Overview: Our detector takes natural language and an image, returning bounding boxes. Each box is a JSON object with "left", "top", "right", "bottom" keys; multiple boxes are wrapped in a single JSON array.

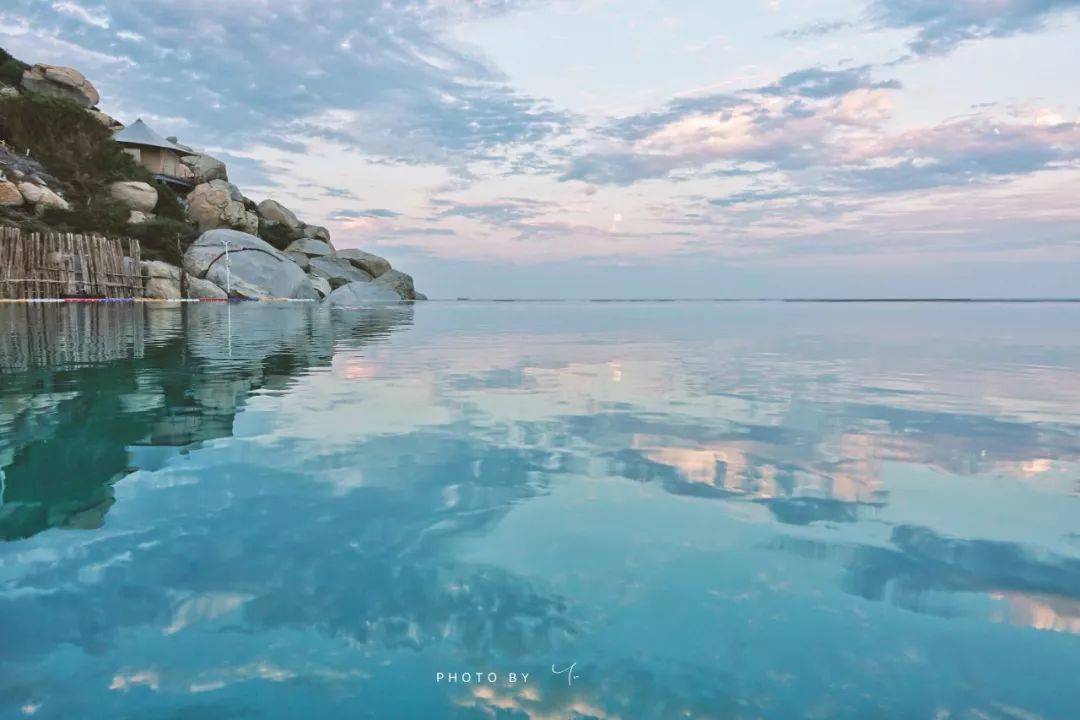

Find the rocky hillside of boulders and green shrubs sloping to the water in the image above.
[{"left": 0, "top": 51, "right": 427, "bottom": 307}]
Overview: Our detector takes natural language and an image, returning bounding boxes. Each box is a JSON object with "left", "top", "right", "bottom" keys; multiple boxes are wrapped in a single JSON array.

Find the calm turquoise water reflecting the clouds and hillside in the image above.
[{"left": 0, "top": 302, "right": 1080, "bottom": 720}]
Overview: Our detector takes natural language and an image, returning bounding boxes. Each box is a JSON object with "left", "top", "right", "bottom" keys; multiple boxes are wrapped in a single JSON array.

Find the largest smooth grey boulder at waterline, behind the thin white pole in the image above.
[{"left": 184, "top": 230, "right": 319, "bottom": 300}]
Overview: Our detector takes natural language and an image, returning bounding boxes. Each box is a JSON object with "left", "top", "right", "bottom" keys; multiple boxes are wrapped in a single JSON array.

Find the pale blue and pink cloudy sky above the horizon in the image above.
[{"left": 0, "top": 0, "right": 1080, "bottom": 298}]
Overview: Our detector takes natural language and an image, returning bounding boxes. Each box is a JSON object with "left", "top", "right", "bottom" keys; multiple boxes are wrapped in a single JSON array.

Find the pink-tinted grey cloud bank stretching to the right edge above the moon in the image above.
[{"left": 559, "top": 49, "right": 1080, "bottom": 207}]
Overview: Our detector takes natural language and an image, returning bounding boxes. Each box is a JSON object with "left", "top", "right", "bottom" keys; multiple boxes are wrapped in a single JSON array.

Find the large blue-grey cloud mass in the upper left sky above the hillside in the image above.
[{"left": 2, "top": 0, "right": 569, "bottom": 163}]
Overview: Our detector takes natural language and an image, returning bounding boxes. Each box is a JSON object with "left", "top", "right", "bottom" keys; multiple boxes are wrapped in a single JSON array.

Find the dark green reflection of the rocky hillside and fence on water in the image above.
[{"left": 0, "top": 304, "right": 413, "bottom": 540}]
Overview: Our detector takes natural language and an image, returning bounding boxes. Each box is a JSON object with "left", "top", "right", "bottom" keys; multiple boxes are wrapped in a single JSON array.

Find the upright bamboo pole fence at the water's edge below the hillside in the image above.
[{"left": 0, "top": 228, "right": 143, "bottom": 299}]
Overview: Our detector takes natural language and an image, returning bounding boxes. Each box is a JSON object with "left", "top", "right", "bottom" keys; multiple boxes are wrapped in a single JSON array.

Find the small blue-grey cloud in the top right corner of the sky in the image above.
[{"left": 868, "top": 0, "right": 1080, "bottom": 55}]
